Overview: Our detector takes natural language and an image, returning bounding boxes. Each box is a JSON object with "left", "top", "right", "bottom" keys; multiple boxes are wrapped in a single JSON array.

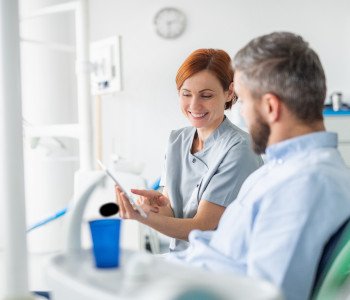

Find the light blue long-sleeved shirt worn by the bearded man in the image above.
[{"left": 170, "top": 132, "right": 350, "bottom": 300}]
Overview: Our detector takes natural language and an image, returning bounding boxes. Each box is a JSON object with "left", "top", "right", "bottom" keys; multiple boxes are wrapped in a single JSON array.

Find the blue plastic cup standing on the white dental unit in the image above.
[{"left": 89, "top": 219, "right": 121, "bottom": 268}]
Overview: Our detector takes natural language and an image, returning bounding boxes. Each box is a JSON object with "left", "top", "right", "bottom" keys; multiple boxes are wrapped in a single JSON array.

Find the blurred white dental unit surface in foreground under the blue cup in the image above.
[{"left": 47, "top": 250, "right": 283, "bottom": 300}]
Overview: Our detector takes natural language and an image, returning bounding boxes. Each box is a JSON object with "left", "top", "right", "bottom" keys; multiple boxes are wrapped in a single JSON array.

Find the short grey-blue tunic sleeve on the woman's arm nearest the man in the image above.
[{"left": 200, "top": 143, "right": 262, "bottom": 207}]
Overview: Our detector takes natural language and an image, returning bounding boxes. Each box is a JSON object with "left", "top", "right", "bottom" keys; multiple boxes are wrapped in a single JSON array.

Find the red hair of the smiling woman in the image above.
[{"left": 175, "top": 49, "right": 235, "bottom": 109}]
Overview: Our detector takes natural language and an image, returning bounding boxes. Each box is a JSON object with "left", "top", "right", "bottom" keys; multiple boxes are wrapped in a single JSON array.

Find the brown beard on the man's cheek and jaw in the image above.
[{"left": 250, "top": 112, "right": 271, "bottom": 154}]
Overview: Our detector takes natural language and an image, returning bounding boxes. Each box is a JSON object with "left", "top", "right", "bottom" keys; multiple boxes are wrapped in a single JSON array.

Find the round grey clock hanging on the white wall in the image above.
[{"left": 154, "top": 7, "right": 186, "bottom": 39}]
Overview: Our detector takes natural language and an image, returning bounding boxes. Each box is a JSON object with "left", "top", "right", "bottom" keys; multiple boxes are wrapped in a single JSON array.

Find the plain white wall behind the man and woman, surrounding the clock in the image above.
[{"left": 90, "top": 0, "right": 350, "bottom": 180}]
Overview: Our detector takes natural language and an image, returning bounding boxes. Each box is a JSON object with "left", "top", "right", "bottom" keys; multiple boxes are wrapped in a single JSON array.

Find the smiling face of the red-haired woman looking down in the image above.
[{"left": 179, "top": 70, "right": 233, "bottom": 132}]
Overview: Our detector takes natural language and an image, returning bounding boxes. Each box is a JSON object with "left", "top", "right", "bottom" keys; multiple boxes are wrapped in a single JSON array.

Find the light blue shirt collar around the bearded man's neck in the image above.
[{"left": 266, "top": 131, "right": 338, "bottom": 161}]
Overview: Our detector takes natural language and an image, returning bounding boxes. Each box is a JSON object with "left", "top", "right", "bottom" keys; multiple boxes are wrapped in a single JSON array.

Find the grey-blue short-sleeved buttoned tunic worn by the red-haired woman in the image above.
[{"left": 160, "top": 117, "right": 263, "bottom": 251}]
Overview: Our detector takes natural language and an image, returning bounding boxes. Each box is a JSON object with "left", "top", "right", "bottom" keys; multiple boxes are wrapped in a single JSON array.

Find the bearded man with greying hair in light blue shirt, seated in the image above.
[{"left": 167, "top": 32, "right": 350, "bottom": 300}]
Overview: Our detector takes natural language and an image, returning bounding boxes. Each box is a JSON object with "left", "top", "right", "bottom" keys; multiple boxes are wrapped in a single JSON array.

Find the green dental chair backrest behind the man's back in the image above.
[{"left": 310, "top": 218, "right": 350, "bottom": 300}]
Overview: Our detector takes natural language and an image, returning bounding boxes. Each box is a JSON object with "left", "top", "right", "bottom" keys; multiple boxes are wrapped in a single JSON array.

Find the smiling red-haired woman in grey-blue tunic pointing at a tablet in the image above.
[{"left": 116, "top": 49, "right": 262, "bottom": 251}]
